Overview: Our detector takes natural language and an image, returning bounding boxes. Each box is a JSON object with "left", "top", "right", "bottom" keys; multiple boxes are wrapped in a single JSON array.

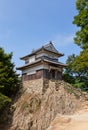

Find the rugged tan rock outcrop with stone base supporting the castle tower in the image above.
[{"left": 9, "top": 79, "right": 86, "bottom": 130}]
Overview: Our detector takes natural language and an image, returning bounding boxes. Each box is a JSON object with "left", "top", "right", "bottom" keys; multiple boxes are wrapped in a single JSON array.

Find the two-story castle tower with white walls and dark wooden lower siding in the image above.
[{"left": 17, "top": 42, "right": 66, "bottom": 94}]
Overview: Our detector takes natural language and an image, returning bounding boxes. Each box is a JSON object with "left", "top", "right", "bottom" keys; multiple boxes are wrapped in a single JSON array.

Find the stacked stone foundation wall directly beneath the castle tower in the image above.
[{"left": 23, "top": 78, "right": 55, "bottom": 94}]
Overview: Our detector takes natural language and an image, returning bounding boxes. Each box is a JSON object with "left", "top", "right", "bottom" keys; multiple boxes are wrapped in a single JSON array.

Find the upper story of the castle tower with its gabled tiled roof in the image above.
[{"left": 20, "top": 42, "right": 64, "bottom": 65}]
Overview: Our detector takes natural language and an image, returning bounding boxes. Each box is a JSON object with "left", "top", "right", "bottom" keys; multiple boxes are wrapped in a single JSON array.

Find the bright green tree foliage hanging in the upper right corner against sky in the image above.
[{"left": 73, "top": 0, "right": 88, "bottom": 49}]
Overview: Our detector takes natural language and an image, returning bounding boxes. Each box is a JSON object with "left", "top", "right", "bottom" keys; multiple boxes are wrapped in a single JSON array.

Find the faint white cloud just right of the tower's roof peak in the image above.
[{"left": 53, "top": 34, "right": 74, "bottom": 47}]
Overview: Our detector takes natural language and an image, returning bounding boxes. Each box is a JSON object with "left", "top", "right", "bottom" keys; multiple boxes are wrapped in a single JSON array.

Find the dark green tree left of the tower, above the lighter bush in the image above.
[{"left": 0, "top": 48, "right": 18, "bottom": 97}]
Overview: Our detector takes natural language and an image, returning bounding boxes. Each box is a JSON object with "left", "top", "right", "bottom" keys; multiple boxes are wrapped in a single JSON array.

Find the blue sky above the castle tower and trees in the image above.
[{"left": 0, "top": 0, "right": 80, "bottom": 72}]
